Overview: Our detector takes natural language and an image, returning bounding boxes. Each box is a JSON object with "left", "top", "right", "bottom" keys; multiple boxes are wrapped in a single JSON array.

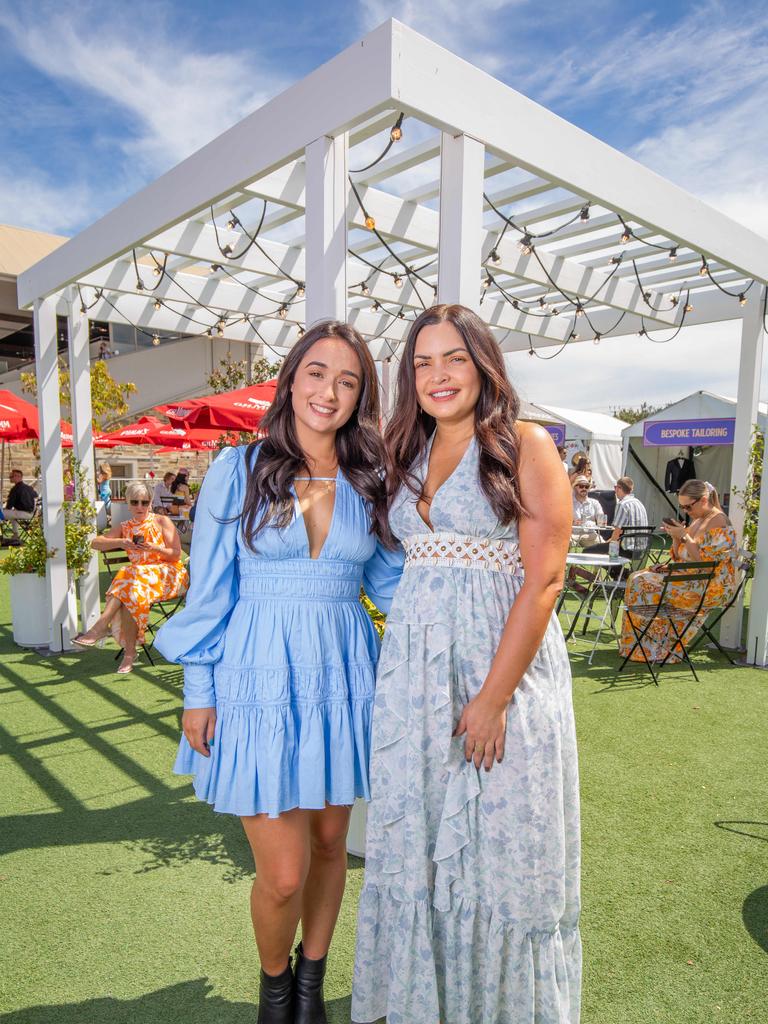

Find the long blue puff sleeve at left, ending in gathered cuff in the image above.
[{"left": 156, "top": 447, "right": 245, "bottom": 709}]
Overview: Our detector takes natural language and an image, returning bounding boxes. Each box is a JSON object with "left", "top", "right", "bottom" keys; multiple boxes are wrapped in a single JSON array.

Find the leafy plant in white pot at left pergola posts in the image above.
[{"left": 0, "top": 459, "right": 96, "bottom": 647}]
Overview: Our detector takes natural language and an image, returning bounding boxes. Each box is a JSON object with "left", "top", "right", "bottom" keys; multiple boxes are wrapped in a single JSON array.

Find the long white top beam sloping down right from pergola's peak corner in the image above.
[{"left": 392, "top": 23, "right": 768, "bottom": 282}]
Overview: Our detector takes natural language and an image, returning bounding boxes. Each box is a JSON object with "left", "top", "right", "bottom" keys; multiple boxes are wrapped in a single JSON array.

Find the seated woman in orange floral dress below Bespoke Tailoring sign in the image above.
[{"left": 618, "top": 480, "right": 738, "bottom": 663}]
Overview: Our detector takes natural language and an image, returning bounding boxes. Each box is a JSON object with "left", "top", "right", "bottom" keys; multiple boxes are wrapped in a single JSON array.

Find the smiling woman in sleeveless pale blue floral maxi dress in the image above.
[{"left": 352, "top": 306, "right": 581, "bottom": 1024}]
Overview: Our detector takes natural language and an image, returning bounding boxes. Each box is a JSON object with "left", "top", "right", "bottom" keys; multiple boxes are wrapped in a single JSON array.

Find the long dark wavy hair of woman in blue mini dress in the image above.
[{"left": 242, "top": 321, "right": 392, "bottom": 550}]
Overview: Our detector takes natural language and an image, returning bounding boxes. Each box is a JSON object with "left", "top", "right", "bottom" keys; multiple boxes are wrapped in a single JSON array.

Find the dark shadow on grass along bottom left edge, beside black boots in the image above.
[{"left": 0, "top": 978, "right": 351, "bottom": 1024}]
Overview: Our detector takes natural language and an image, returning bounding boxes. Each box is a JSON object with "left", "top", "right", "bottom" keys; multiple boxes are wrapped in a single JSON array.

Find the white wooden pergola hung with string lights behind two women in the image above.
[{"left": 18, "top": 20, "right": 768, "bottom": 665}]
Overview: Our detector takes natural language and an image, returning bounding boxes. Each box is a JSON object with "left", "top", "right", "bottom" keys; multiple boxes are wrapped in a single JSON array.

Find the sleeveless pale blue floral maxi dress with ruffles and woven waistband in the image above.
[{"left": 352, "top": 441, "right": 582, "bottom": 1024}]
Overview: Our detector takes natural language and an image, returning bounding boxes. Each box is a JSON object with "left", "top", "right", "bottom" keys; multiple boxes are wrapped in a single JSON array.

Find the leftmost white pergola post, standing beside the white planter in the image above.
[{"left": 34, "top": 297, "right": 72, "bottom": 651}]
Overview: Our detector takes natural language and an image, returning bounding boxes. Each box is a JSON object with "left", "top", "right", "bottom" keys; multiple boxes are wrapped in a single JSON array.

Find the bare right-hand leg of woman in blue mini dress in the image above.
[{"left": 301, "top": 807, "right": 352, "bottom": 959}]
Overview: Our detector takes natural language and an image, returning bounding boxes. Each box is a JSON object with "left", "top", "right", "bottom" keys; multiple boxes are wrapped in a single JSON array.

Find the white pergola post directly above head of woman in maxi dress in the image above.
[{"left": 437, "top": 132, "right": 485, "bottom": 311}]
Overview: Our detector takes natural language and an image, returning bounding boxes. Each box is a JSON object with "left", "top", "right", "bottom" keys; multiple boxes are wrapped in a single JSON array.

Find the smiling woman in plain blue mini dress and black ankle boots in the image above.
[{"left": 158, "top": 322, "right": 402, "bottom": 1024}]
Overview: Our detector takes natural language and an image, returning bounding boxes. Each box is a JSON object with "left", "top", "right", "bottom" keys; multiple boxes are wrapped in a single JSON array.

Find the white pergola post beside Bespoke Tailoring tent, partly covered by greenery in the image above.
[{"left": 720, "top": 288, "right": 763, "bottom": 649}]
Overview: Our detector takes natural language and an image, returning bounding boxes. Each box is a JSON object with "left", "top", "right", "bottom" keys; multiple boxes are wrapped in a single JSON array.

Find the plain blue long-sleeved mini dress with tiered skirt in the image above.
[{"left": 156, "top": 446, "right": 403, "bottom": 817}]
